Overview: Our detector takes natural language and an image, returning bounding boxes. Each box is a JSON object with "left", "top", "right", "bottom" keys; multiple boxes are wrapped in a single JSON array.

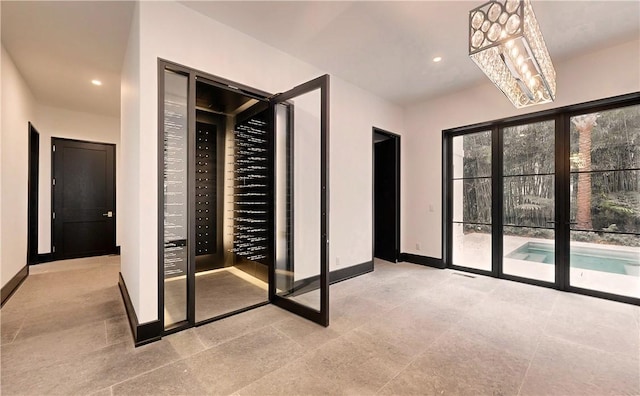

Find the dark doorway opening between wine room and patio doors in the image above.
[{"left": 373, "top": 128, "right": 400, "bottom": 263}]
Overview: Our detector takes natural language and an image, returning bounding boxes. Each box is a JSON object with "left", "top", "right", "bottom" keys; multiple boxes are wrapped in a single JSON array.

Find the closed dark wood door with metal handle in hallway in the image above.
[{"left": 52, "top": 138, "right": 116, "bottom": 259}]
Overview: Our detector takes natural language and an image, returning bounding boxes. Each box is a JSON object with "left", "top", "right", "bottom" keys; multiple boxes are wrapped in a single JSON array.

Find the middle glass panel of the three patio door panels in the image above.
[{"left": 502, "top": 120, "right": 556, "bottom": 282}]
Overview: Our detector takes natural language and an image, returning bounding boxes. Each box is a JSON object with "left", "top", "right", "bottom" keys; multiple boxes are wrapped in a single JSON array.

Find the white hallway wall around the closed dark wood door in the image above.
[{"left": 34, "top": 105, "right": 122, "bottom": 253}]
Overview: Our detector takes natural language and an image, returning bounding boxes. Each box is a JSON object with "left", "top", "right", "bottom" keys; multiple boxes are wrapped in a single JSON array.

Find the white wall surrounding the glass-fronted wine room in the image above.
[{"left": 122, "top": 2, "right": 403, "bottom": 322}]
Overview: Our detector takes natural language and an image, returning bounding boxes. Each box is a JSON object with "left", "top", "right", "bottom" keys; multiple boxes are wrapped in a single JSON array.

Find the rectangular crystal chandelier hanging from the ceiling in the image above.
[{"left": 469, "top": 0, "right": 556, "bottom": 108}]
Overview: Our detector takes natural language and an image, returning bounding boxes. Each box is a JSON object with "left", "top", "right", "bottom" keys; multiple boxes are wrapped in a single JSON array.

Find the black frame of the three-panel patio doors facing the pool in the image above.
[{"left": 442, "top": 92, "right": 640, "bottom": 305}]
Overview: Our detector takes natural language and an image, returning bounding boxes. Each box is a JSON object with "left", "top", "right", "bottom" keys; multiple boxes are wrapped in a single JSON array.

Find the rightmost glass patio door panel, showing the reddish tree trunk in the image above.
[{"left": 569, "top": 105, "right": 640, "bottom": 298}]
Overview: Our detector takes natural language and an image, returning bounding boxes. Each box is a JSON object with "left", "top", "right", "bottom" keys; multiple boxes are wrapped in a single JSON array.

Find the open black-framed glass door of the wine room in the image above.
[{"left": 269, "top": 75, "right": 329, "bottom": 326}]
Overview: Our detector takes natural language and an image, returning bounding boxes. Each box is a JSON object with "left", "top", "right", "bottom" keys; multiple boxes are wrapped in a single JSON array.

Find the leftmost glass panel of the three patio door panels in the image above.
[{"left": 451, "top": 131, "right": 492, "bottom": 271}]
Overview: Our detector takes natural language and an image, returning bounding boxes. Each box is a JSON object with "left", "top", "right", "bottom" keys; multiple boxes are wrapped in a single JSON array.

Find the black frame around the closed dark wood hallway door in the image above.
[{"left": 47, "top": 136, "right": 118, "bottom": 261}]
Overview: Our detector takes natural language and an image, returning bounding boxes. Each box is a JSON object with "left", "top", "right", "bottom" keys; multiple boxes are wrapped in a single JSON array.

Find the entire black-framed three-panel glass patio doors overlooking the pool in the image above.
[{"left": 443, "top": 93, "right": 640, "bottom": 304}]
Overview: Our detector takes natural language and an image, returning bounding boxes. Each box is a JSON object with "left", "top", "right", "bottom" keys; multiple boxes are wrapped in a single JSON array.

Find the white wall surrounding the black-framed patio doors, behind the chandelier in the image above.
[{"left": 402, "top": 39, "right": 640, "bottom": 258}]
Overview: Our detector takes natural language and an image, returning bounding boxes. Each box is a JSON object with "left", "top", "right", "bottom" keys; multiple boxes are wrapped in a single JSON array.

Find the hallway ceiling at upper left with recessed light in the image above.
[{"left": 0, "top": 0, "right": 134, "bottom": 117}]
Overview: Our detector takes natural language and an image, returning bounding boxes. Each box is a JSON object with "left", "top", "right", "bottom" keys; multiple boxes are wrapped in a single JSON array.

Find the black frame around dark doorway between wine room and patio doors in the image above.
[{"left": 371, "top": 127, "right": 401, "bottom": 262}]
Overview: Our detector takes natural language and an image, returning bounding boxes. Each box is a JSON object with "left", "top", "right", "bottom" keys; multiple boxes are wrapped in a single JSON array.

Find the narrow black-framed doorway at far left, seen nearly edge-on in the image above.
[{"left": 27, "top": 122, "right": 40, "bottom": 265}]
